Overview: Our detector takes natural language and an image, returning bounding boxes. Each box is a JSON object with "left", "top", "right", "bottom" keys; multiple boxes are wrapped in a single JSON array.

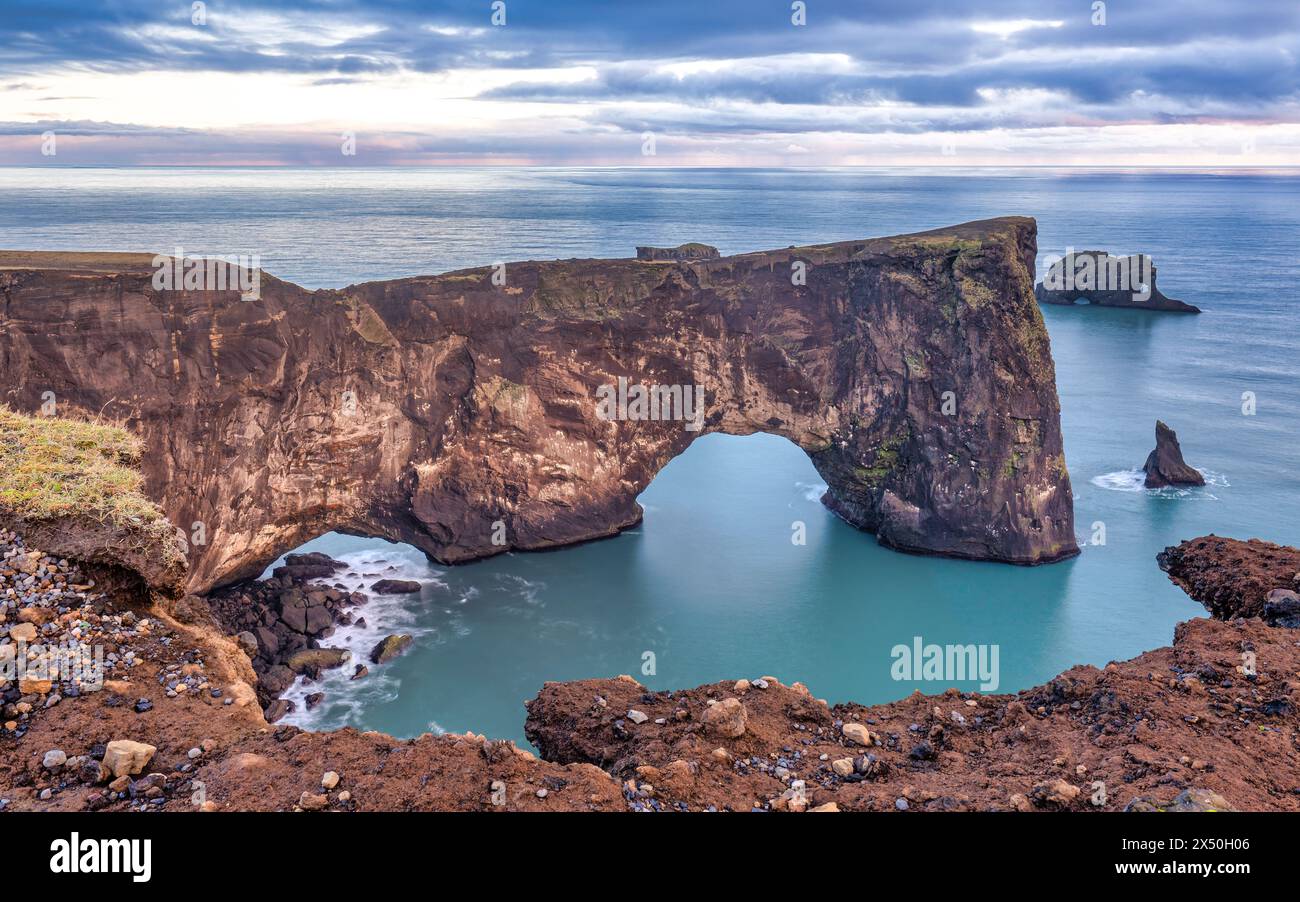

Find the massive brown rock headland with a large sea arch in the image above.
[{"left": 0, "top": 217, "right": 1078, "bottom": 591}]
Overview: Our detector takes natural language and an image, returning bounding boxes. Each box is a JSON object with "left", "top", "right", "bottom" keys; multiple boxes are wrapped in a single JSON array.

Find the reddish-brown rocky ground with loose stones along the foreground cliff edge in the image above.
[{"left": 0, "top": 534, "right": 1300, "bottom": 812}]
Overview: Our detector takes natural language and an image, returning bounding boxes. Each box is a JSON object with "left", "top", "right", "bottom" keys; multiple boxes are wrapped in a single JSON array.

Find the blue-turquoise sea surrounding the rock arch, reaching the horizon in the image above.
[{"left": 0, "top": 169, "right": 1300, "bottom": 740}]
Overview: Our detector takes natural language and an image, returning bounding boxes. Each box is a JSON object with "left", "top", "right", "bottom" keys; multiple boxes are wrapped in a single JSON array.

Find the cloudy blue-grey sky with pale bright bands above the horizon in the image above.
[{"left": 0, "top": 0, "right": 1300, "bottom": 166}]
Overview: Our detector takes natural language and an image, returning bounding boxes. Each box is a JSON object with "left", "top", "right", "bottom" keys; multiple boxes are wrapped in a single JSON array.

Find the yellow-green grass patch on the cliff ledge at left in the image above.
[{"left": 0, "top": 406, "right": 173, "bottom": 534}]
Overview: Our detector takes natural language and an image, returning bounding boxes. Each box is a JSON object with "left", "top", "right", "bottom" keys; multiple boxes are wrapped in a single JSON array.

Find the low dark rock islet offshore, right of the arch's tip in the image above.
[{"left": 1034, "top": 251, "right": 1201, "bottom": 313}]
